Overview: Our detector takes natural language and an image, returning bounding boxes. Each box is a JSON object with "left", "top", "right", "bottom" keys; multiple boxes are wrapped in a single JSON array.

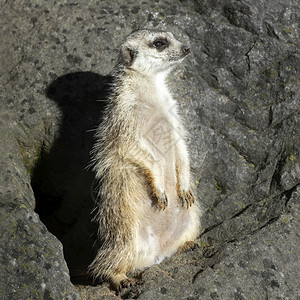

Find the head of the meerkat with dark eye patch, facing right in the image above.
[{"left": 121, "top": 30, "right": 190, "bottom": 74}]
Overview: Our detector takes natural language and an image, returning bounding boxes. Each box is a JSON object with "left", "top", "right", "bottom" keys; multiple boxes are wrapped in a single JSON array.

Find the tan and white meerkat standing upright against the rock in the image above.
[{"left": 89, "top": 30, "right": 200, "bottom": 290}]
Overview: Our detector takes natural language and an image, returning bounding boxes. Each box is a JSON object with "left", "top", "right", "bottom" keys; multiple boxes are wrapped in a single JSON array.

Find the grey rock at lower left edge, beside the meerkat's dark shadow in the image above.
[{"left": 0, "top": 123, "right": 78, "bottom": 299}]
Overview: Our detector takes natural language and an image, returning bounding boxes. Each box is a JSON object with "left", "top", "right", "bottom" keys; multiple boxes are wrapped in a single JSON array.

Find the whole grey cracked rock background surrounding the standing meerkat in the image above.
[{"left": 0, "top": 0, "right": 300, "bottom": 300}]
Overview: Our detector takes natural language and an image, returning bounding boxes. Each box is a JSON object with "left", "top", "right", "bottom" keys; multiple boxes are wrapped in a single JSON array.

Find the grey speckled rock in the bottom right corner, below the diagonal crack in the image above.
[{"left": 193, "top": 187, "right": 300, "bottom": 299}]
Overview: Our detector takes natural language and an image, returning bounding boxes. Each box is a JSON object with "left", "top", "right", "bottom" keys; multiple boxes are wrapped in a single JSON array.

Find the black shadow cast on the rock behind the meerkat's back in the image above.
[{"left": 31, "top": 72, "right": 112, "bottom": 282}]
